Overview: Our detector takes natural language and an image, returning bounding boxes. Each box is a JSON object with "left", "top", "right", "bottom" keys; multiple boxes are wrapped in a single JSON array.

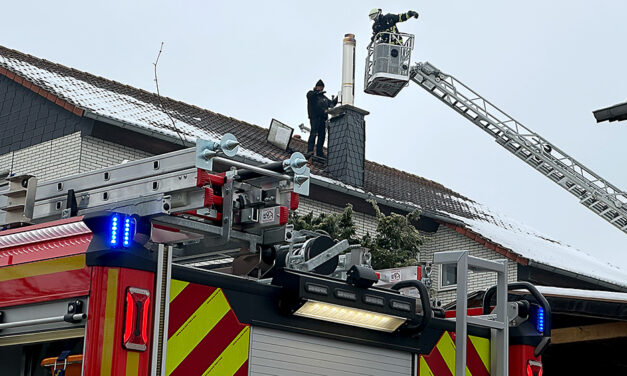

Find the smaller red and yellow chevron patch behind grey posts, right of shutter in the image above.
[{"left": 419, "top": 332, "right": 490, "bottom": 376}]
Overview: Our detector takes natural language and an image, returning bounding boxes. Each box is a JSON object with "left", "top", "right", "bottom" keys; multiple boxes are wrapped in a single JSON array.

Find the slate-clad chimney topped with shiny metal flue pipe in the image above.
[{"left": 325, "top": 34, "right": 369, "bottom": 187}]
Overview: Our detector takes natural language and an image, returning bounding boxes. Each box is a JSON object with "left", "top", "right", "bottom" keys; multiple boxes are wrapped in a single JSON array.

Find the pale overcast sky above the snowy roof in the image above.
[{"left": 0, "top": 0, "right": 627, "bottom": 269}]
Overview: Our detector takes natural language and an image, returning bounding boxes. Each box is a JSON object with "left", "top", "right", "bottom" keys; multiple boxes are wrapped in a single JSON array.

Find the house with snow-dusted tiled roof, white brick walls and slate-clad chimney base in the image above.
[{"left": 0, "top": 47, "right": 627, "bottom": 303}]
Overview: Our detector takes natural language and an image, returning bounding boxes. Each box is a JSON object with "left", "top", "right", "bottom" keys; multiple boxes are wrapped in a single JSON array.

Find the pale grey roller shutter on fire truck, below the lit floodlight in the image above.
[{"left": 249, "top": 326, "right": 412, "bottom": 376}]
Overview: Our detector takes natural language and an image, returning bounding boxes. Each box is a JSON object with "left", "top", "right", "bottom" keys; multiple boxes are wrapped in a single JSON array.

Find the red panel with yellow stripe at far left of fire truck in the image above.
[{"left": 0, "top": 254, "right": 91, "bottom": 307}]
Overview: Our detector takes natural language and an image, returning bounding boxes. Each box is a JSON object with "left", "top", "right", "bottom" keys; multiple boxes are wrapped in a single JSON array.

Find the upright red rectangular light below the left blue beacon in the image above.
[{"left": 122, "top": 287, "right": 150, "bottom": 351}]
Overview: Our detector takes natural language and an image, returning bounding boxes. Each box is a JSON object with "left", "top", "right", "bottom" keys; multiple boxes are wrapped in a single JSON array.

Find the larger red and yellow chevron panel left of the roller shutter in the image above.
[{"left": 166, "top": 280, "right": 250, "bottom": 376}]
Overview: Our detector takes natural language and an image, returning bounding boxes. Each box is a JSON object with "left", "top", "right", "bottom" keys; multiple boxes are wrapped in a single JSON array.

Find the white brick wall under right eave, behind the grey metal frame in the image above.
[{"left": 420, "top": 226, "right": 518, "bottom": 304}]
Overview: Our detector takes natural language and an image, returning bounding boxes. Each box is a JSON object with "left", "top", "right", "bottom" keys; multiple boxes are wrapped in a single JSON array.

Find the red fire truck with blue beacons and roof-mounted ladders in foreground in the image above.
[{"left": 0, "top": 135, "right": 550, "bottom": 376}]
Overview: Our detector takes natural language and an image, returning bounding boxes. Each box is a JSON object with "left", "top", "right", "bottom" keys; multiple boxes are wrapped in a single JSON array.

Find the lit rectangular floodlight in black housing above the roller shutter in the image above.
[{"left": 272, "top": 269, "right": 420, "bottom": 333}]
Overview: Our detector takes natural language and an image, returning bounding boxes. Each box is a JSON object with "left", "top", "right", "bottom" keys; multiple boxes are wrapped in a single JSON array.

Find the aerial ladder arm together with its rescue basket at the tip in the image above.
[{"left": 364, "top": 33, "right": 627, "bottom": 234}]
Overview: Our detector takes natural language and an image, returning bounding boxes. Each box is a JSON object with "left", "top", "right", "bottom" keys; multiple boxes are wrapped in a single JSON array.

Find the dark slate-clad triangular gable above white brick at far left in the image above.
[{"left": 0, "top": 76, "right": 93, "bottom": 155}]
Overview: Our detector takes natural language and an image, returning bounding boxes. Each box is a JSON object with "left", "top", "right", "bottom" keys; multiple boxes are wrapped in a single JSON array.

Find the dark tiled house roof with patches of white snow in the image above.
[{"left": 0, "top": 46, "right": 627, "bottom": 290}]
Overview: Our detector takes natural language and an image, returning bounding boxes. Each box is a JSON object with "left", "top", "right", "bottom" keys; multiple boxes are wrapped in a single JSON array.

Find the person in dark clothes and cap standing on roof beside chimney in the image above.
[{"left": 307, "top": 80, "right": 337, "bottom": 158}]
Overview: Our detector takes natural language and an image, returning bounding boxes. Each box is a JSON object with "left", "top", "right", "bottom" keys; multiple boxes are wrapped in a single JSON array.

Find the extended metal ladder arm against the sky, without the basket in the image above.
[{"left": 411, "top": 62, "right": 627, "bottom": 234}]
